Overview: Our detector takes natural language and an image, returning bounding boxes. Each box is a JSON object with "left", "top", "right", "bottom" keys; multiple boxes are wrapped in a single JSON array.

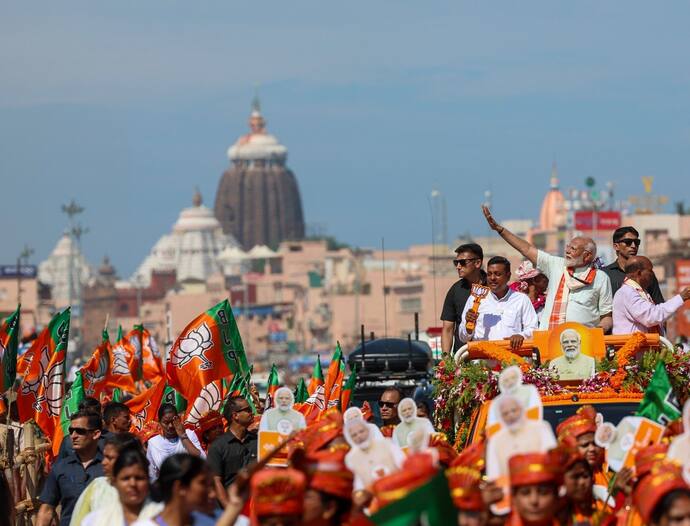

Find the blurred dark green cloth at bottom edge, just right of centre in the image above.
[{"left": 370, "top": 471, "right": 457, "bottom": 526}]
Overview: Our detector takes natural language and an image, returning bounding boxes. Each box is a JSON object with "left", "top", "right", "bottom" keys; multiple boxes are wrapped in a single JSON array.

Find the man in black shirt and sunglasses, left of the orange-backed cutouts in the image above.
[{"left": 207, "top": 396, "right": 257, "bottom": 507}]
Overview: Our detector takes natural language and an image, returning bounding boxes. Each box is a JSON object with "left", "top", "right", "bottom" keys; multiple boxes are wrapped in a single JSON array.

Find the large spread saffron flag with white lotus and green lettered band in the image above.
[{"left": 166, "top": 299, "right": 250, "bottom": 400}]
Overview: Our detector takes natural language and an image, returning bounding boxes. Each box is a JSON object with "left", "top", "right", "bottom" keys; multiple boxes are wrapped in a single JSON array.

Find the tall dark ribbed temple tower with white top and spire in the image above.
[{"left": 215, "top": 98, "right": 304, "bottom": 250}]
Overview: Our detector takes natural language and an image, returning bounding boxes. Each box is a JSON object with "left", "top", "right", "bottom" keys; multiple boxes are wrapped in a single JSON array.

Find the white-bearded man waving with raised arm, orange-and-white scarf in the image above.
[{"left": 482, "top": 206, "right": 613, "bottom": 332}]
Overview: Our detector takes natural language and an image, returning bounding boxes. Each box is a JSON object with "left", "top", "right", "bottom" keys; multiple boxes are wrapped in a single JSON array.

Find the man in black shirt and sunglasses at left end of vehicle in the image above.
[{"left": 441, "top": 243, "right": 486, "bottom": 354}]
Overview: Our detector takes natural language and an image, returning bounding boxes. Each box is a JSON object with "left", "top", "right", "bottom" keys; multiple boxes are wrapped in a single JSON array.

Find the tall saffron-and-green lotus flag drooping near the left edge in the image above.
[{"left": 17, "top": 308, "right": 70, "bottom": 452}]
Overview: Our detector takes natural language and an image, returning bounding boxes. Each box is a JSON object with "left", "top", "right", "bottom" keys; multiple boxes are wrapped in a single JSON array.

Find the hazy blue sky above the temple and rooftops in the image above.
[{"left": 0, "top": 0, "right": 690, "bottom": 276}]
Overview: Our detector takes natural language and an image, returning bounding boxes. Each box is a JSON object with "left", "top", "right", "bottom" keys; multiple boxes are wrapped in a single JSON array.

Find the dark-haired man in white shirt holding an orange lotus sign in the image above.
[{"left": 458, "top": 256, "right": 537, "bottom": 349}]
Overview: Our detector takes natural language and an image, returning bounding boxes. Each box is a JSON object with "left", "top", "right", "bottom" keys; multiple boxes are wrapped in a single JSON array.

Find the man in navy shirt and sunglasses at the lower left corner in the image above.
[{"left": 36, "top": 411, "right": 103, "bottom": 526}]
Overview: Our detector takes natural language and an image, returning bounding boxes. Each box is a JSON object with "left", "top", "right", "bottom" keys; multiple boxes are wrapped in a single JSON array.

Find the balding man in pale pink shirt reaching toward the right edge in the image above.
[{"left": 612, "top": 256, "right": 690, "bottom": 334}]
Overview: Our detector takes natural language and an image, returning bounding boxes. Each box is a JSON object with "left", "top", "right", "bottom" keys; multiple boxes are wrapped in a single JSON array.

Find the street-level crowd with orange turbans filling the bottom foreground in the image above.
[{"left": 0, "top": 384, "right": 690, "bottom": 526}]
